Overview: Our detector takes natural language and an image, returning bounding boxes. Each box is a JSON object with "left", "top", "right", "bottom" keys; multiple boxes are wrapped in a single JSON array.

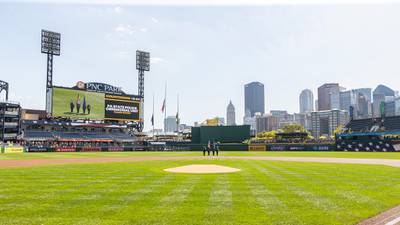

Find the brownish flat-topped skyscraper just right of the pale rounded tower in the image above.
[{"left": 318, "top": 83, "right": 340, "bottom": 111}]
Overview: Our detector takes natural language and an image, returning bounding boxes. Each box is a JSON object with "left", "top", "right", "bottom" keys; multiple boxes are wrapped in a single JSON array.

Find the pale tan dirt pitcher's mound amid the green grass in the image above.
[{"left": 164, "top": 164, "right": 240, "bottom": 173}]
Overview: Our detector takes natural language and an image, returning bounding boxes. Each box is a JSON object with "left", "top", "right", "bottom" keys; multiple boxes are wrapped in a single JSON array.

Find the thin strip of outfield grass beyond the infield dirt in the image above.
[{"left": 0, "top": 151, "right": 400, "bottom": 160}]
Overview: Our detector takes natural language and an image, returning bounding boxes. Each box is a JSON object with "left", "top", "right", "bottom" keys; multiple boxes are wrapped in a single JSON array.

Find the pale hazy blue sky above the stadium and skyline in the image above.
[{"left": 0, "top": 0, "right": 400, "bottom": 130}]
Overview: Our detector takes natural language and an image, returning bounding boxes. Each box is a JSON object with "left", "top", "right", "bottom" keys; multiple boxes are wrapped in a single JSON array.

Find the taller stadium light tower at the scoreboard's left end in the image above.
[{"left": 41, "top": 30, "right": 61, "bottom": 113}]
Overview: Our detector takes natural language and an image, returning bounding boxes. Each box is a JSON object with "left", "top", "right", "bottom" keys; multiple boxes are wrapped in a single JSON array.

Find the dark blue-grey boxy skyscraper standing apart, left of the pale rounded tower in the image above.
[{"left": 244, "top": 82, "right": 265, "bottom": 117}]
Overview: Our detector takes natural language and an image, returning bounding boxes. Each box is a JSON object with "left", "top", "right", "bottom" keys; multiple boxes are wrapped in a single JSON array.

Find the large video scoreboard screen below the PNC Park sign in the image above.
[{"left": 52, "top": 87, "right": 140, "bottom": 121}]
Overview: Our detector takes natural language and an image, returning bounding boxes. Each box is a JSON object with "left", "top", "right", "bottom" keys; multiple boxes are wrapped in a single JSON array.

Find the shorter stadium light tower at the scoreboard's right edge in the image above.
[{"left": 136, "top": 50, "right": 150, "bottom": 132}]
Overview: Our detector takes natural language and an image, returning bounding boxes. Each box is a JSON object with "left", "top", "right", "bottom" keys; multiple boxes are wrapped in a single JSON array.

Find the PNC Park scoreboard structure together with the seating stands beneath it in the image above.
[{"left": 18, "top": 81, "right": 143, "bottom": 152}]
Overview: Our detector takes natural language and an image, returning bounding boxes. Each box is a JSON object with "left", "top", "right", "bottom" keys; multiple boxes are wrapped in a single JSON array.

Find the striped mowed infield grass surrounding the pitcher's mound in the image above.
[{"left": 0, "top": 160, "right": 400, "bottom": 224}]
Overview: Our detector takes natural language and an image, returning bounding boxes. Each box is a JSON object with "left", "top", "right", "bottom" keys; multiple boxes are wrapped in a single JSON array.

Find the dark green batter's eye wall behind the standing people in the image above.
[{"left": 192, "top": 125, "right": 250, "bottom": 144}]
